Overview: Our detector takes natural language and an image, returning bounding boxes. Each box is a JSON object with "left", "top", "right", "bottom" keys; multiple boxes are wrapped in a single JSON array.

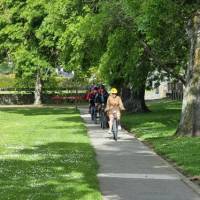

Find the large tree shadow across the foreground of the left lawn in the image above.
[{"left": 0, "top": 142, "right": 98, "bottom": 200}]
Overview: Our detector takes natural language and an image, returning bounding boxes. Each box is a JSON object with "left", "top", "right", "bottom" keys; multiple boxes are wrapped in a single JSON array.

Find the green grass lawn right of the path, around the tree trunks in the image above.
[{"left": 122, "top": 100, "right": 200, "bottom": 176}]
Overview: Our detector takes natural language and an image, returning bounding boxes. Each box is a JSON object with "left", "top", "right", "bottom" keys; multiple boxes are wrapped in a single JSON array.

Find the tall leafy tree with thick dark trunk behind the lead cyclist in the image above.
[{"left": 60, "top": 0, "right": 152, "bottom": 112}]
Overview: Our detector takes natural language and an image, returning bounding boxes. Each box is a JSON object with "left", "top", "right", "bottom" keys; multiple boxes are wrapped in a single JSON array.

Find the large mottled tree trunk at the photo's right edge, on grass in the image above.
[{"left": 177, "top": 11, "right": 200, "bottom": 136}]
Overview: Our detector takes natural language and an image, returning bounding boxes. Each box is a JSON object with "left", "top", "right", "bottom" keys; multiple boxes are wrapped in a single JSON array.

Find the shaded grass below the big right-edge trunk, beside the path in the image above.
[{"left": 148, "top": 136, "right": 200, "bottom": 175}]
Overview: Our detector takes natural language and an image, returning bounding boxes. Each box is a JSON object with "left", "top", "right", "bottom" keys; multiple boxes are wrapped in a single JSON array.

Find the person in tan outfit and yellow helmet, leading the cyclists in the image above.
[{"left": 105, "top": 88, "right": 125, "bottom": 133}]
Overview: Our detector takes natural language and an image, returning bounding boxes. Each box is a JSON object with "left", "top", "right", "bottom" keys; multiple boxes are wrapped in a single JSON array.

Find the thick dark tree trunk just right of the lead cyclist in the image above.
[{"left": 121, "top": 85, "right": 149, "bottom": 113}]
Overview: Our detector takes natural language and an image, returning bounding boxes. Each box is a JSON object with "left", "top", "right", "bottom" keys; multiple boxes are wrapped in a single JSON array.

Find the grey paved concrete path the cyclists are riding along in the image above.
[{"left": 80, "top": 108, "right": 200, "bottom": 200}]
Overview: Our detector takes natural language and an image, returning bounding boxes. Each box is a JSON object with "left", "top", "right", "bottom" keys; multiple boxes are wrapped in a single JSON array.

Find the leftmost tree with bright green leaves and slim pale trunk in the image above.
[{"left": 0, "top": 0, "right": 55, "bottom": 104}]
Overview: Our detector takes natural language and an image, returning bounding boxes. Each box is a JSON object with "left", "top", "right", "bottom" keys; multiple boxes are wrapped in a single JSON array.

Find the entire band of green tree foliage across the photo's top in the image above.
[{"left": 0, "top": 0, "right": 197, "bottom": 94}]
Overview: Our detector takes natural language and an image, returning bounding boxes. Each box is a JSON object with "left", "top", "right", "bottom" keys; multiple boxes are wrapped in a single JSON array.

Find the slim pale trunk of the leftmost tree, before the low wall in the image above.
[{"left": 34, "top": 72, "right": 42, "bottom": 105}]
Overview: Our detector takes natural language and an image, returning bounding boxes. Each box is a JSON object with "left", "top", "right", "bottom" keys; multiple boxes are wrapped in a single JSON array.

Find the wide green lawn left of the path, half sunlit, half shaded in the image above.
[{"left": 0, "top": 107, "right": 101, "bottom": 200}]
